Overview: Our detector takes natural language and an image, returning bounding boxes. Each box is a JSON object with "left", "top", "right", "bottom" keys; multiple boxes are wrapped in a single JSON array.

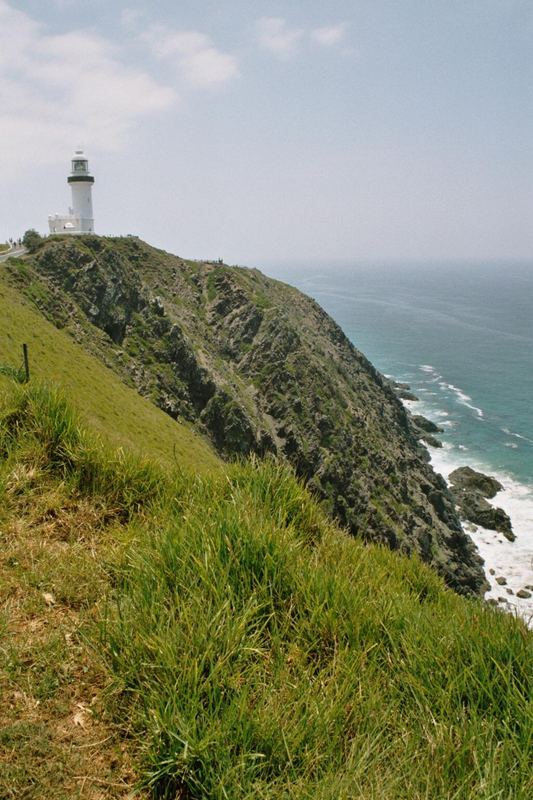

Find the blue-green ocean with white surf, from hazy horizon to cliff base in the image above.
[{"left": 267, "top": 262, "right": 533, "bottom": 623}]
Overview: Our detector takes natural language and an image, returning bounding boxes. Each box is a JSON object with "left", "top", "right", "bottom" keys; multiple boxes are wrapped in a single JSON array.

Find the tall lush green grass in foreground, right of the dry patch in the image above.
[{"left": 103, "top": 464, "right": 533, "bottom": 800}]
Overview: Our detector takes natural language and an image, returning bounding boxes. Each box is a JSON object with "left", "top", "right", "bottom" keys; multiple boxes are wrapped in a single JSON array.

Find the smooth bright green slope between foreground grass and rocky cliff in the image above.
[{"left": 0, "top": 274, "right": 220, "bottom": 472}]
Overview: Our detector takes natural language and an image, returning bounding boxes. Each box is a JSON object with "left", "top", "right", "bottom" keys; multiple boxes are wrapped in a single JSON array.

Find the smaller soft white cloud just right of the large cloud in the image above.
[{"left": 141, "top": 25, "right": 239, "bottom": 89}]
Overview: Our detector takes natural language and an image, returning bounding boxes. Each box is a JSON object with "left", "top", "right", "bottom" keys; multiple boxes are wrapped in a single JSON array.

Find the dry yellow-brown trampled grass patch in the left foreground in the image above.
[{"left": 0, "top": 463, "right": 145, "bottom": 800}]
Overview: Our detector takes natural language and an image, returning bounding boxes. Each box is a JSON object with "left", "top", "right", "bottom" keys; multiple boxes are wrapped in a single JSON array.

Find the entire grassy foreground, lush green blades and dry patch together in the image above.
[{"left": 0, "top": 386, "right": 533, "bottom": 800}]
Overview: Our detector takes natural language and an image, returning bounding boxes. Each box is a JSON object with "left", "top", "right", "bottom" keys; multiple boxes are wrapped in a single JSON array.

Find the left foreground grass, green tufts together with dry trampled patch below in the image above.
[{"left": 0, "top": 384, "right": 154, "bottom": 800}]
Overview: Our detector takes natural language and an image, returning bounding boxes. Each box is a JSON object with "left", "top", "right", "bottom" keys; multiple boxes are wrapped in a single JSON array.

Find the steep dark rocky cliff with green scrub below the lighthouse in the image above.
[{"left": 10, "top": 236, "right": 484, "bottom": 593}]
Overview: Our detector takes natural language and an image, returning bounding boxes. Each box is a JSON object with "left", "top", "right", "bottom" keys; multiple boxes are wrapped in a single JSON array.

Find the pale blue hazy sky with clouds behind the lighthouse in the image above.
[{"left": 0, "top": 0, "right": 533, "bottom": 266}]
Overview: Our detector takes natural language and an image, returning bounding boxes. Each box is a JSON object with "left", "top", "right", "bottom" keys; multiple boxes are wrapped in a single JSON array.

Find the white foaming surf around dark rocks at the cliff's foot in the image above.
[{"left": 429, "top": 442, "right": 533, "bottom": 628}]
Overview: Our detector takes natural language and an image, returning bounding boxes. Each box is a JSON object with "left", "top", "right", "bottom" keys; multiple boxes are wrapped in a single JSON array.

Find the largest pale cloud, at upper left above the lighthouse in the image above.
[{"left": 0, "top": 0, "right": 177, "bottom": 176}]
